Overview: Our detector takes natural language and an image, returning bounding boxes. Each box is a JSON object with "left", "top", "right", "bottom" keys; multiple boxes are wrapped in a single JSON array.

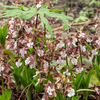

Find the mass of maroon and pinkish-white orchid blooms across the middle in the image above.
[{"left": 2, "top": 6, "right": 100, "bottom": 100}]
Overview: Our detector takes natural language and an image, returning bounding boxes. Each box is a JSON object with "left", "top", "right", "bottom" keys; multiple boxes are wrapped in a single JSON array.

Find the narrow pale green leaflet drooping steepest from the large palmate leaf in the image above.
[{"left": 40, "top": 14, "right": 53, "bottom": 38}]
